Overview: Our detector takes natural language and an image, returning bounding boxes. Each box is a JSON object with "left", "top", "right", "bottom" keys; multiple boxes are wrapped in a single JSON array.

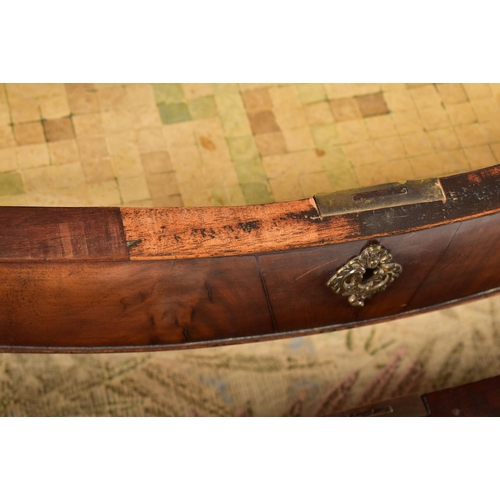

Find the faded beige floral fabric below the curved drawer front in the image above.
[{"left": 0, "top": 297, "right": 500, "bottom": 416}]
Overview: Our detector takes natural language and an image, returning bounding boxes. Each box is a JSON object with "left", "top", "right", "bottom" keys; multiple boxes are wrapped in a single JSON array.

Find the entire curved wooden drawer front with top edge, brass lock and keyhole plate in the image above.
[{"left": 0, "top": 166, "right": 500, "bottom": 352}]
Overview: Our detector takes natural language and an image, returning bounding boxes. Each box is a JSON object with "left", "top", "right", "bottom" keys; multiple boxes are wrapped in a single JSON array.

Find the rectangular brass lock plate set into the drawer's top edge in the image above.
[{"left": 314, "top": 179, "right": 446, "bottom": 217}]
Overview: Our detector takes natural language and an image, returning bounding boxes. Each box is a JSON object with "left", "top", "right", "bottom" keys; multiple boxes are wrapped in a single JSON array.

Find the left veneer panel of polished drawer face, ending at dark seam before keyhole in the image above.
[{"left": 0, "top": 257, "right": 274, "bottom": 350}]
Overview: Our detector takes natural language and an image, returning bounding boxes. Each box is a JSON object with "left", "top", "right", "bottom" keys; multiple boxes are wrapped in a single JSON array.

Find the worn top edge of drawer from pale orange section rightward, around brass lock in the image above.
[{"left": 120, "top": 166, "right": 500, "bottom": 260}]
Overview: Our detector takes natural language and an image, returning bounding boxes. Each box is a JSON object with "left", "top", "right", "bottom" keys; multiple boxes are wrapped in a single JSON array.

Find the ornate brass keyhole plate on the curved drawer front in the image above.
[{"left": 327, "top": 245, "right": 403, "bottom": 307}]
